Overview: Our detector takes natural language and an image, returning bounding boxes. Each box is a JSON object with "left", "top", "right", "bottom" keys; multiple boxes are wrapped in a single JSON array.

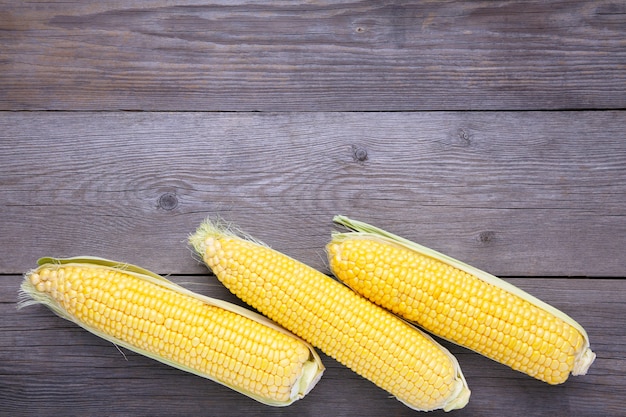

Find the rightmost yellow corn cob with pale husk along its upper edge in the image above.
[{"left": 326, "top": 216, "right": 595, "bottom": 384}]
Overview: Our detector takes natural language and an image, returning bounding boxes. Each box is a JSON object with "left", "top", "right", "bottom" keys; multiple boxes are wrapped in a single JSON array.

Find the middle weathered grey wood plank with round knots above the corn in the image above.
[{"left": 0, "top": 112, "right": 626, "bottom": 276}]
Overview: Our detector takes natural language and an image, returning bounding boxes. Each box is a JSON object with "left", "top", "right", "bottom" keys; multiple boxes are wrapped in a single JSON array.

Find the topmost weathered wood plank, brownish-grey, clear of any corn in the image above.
[{"left": 0, "top": 0, "right": 626, "bottom": 111}]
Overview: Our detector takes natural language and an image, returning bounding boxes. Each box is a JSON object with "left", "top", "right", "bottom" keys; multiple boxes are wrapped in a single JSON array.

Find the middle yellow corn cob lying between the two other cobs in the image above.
[{"left": 190, "top": 221, "right": 470, "bottom": 411}]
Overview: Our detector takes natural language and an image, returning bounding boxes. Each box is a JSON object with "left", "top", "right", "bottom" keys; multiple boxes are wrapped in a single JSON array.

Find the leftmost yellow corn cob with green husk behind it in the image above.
[{"left": 19, "top": 257, "right": 324, "bottom": 406}]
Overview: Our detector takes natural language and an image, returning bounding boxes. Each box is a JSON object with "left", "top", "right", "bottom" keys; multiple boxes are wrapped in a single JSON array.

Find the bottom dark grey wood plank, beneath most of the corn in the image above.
[{"left": 0, "top": 276, "right": 626, "bottom": 417}]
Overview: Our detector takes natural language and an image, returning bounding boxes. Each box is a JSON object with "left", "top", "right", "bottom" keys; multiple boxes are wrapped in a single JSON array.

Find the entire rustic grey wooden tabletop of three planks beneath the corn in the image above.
[{"left": 0, "top": 0, "right": 626, "bottom": 417}]
